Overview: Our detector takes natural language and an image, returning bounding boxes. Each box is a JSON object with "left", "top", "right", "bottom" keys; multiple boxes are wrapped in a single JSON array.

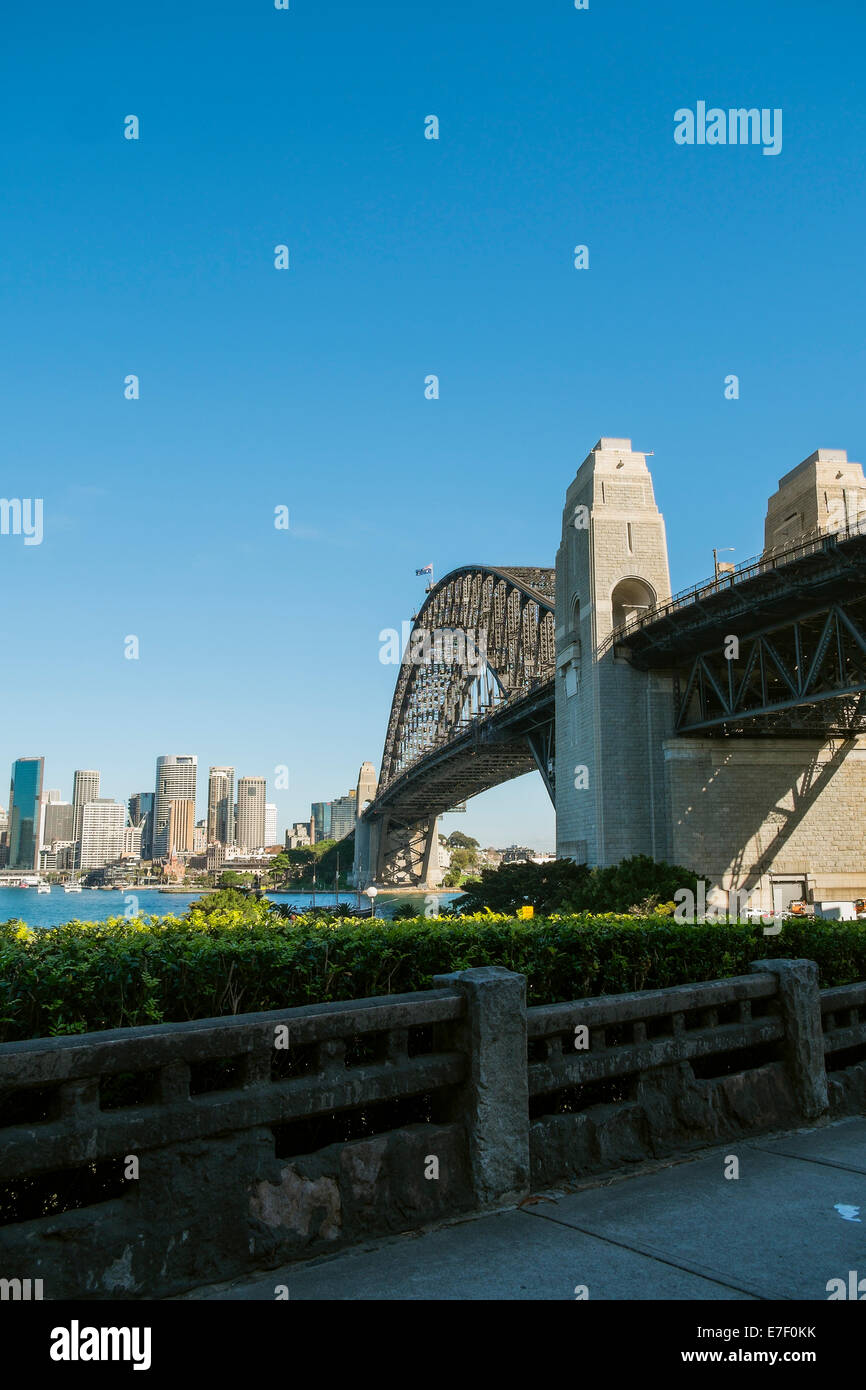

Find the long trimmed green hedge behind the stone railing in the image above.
[{"left": 0, "top": 905, "right": 866, "bottom": 1041}]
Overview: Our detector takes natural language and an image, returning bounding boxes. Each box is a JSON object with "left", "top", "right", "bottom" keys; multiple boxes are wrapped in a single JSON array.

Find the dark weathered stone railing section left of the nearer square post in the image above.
[{"left": 0, "top": 990, "right": 473, "bottom": 1298}]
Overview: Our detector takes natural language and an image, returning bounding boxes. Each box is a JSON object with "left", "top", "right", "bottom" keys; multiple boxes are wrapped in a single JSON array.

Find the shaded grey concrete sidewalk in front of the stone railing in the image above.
[{"left": 182, "top": 1119, "right": 866, "bottom": 1301}]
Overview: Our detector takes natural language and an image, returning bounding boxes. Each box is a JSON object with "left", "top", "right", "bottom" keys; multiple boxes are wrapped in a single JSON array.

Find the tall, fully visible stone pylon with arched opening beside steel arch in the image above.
[{"left": 556, "top": 439, "right": 673, "bottom": 865}]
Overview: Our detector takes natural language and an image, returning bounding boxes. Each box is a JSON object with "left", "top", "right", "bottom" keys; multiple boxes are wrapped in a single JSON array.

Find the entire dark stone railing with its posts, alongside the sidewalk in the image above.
[{"left": 0, "top": 959, "right": 866, "bottom": 1298}]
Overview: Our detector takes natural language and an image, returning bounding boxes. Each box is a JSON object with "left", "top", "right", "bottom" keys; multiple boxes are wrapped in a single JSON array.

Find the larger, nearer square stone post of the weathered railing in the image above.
[{"left": 434, "top": 965, "right": 530, "bottom": 1207}]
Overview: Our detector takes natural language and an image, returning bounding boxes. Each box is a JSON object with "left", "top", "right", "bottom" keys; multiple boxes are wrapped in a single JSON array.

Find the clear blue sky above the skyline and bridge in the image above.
[{"left": 0, "top": 0, "right": 866, "bottom": 845}]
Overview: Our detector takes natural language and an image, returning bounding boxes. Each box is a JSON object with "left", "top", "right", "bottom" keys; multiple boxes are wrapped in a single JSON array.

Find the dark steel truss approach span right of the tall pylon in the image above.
[{"left": 619, "top": 523, "right": 866, "bottom": 738}]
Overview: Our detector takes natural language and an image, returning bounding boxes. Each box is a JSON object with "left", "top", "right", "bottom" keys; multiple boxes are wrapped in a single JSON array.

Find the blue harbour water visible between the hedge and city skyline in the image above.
[{"left": 0, "top": 885, "right": 459, "bottom": 927}]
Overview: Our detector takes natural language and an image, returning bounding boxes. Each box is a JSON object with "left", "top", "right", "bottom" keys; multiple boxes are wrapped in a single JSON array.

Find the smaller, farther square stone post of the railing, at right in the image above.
[{"left": 752, "top": 960, "right": 828, "bottom": 1120}]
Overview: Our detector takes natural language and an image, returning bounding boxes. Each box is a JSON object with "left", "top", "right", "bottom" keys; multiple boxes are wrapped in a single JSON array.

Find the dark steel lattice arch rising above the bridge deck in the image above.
[{"left": 377, "top": 564, "right": 556, "bottom": 796}]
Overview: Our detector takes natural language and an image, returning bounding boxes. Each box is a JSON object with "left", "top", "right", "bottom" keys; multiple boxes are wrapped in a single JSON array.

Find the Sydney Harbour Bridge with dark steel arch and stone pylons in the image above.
[{"left": 356, "top": 439, "right": 866, "bottom": 906}]
